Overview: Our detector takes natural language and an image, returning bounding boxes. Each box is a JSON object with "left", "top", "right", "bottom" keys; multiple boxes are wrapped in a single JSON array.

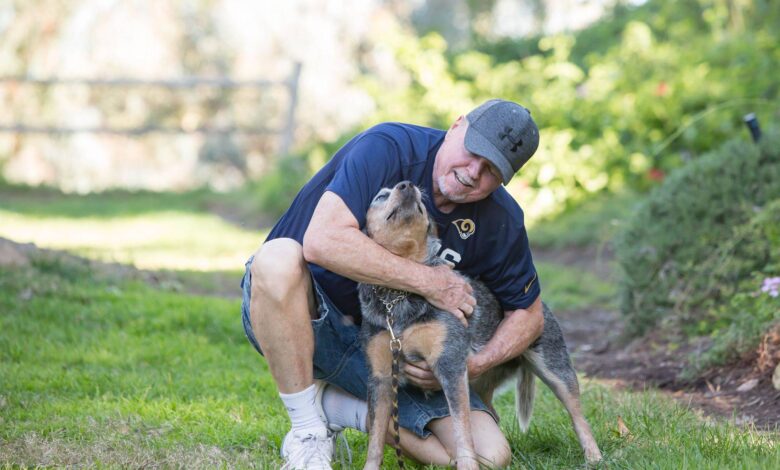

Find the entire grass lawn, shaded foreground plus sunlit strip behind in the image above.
[{"left": 0, "top": 186, "right": 780, "bottom": 469}]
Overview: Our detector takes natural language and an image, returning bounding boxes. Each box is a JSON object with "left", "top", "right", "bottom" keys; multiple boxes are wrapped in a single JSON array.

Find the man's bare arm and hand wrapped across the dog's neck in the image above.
[{"left": 303, "top": 191, "right": 476, "bottom": 321}]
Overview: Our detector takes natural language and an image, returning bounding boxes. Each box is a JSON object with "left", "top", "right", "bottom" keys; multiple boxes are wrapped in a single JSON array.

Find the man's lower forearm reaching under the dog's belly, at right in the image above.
[{"left": 469, "top": 298, "right": 544, "bottom": 377}]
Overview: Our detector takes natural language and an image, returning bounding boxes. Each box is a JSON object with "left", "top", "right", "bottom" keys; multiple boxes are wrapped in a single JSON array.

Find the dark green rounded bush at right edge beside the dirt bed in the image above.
[{"left": 615, "top": 126, "right": 780, "bottom": 334}]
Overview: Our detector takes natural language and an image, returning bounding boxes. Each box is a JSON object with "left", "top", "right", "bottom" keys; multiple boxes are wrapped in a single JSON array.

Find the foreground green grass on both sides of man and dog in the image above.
[{"left": 0, "top": 257, "right": 780, "bottom": 469}]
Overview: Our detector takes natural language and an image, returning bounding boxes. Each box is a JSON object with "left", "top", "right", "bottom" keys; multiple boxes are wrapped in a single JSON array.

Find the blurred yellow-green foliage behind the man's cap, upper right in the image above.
[{"left": 348, "top": 0, "right": 780, "bottom": 220}]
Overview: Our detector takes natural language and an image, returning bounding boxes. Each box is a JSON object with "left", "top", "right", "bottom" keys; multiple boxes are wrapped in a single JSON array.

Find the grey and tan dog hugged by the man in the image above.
[{"left": 358, "top": 181, "right": 601, "bottom": 469}]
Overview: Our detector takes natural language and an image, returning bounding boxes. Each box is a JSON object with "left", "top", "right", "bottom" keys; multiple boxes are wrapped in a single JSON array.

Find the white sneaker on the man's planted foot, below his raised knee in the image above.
[{"left": 282, "top": 430, "right": 334, "bottom": 470}]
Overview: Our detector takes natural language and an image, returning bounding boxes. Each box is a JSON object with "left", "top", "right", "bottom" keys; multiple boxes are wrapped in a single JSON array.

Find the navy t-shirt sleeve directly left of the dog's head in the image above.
[{"left": 325, "top": 133, "right": 401, "bottom": 228}]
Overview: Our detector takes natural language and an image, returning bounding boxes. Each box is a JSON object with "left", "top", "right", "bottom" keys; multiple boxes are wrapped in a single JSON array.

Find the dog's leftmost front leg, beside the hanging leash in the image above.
[{"left": 363, "top": 331, "right": 393, "bottom": 470}]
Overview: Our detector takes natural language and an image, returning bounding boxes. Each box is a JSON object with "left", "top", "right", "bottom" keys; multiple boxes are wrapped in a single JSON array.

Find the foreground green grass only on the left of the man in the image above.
[{"left": 0, "top": 260, "right": 284, "bottom": 466}]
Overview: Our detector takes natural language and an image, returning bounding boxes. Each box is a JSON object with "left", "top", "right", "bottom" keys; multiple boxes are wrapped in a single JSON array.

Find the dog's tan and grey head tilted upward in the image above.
[{"left": 366, "top": 181, "right": 435, "bottom": 262}]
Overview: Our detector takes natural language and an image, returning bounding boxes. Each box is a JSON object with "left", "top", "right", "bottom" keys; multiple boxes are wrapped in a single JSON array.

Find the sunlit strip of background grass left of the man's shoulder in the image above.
[{"left": 0, "top": 187, "right": 267, "bottom": 273}]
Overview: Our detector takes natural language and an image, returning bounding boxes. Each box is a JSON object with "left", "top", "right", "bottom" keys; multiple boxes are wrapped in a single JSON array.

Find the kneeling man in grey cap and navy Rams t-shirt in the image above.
[{"left": 242, "top": 100, "right": 544, "bottom": 469}]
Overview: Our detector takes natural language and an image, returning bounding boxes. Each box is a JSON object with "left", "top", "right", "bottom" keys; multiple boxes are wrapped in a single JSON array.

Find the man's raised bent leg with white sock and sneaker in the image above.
[{"left": 249, "top": 239, "right": 333, "bottom": 470}]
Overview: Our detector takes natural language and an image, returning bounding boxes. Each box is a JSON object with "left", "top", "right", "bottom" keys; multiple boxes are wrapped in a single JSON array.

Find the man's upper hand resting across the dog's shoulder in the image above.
[{"left": 421, "top": 265, "right": 477, "bottom": 325}]
